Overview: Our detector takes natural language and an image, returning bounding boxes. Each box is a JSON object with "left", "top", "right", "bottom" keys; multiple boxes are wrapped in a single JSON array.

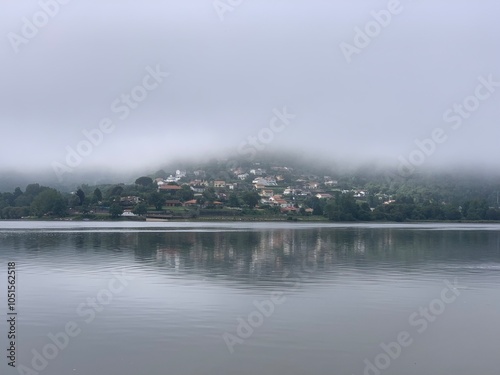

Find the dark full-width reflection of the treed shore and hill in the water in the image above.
[{"left": 0, "top": 227, "right": 500, "bottom": 279}]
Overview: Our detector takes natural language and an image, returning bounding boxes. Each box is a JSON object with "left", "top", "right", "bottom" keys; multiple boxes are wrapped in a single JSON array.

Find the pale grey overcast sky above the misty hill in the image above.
[{"left": 0, "top": 0, "right": 500, "bottom": 177}]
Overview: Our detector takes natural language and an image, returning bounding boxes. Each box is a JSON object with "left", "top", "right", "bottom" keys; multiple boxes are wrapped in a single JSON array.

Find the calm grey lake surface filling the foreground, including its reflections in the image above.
[{"left": 0, "top": 222, "right": 500, "bottom": 375}]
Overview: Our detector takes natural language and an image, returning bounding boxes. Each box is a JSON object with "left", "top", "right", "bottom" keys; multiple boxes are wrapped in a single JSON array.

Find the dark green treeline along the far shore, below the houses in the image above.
[{"left": 0, "top": 177, "right": 500, "bottom": 222}]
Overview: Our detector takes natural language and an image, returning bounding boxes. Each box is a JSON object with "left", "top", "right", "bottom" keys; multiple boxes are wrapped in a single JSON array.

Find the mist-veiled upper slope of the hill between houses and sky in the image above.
[{"left": 0, "top": 151, "right": 500, "bottom": 198}]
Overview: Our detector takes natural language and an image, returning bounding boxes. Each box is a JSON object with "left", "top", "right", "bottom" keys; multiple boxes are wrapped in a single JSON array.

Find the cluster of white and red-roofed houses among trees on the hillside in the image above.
[{"left": 105, "top": 163, "right": 376, "bottom": 219}]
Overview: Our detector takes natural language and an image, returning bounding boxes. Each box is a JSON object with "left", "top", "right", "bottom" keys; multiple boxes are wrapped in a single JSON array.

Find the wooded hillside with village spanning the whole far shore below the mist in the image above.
[{"left": 0, "top": 161, "right": 500, "bottom": 222}]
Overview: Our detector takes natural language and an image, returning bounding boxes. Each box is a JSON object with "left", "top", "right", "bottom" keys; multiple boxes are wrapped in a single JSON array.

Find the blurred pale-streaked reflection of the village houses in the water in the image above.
[{"left": 148, "top": 228, "right": 395, "bottom": 278}]
